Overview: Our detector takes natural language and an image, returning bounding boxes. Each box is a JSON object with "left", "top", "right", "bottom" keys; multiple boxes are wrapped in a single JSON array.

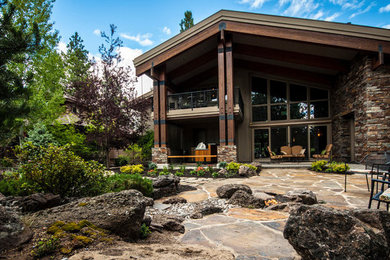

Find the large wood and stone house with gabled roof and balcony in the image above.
[{"left": 134, "top": 10, "right": 390, "bottom": 163}]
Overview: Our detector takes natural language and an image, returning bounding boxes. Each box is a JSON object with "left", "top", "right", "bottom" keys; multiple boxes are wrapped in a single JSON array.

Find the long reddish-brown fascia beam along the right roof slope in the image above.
[{"left": 226, "top": 21, "right": 390, "bottom": 53}]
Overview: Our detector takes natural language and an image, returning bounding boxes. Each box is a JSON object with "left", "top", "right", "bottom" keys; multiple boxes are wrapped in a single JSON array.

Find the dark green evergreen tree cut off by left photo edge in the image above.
[{"left": 0, "top": 1, "right": 40, "bottom": 143}]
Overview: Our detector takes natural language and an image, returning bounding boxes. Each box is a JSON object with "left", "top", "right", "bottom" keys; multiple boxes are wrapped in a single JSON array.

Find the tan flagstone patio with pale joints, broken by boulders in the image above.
[{"left": 157, "top": 169, "right": 369, "bottom": 259}]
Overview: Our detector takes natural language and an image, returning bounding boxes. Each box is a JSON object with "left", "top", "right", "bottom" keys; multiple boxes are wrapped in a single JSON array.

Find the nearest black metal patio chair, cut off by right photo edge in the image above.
[{"left": 368, "top": 170, "right": 390, "bottom": 211}]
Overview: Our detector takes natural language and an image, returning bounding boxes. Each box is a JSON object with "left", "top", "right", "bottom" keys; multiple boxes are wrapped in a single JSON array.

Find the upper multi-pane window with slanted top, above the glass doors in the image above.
[{"left": 251, "top": 77, "right": 329, "bottom": 122}]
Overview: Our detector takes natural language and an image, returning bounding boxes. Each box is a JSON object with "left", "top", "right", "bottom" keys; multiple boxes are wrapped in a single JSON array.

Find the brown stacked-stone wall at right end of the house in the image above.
[{"left": 331, "top": 56, "right": 390, "bottom": 161}]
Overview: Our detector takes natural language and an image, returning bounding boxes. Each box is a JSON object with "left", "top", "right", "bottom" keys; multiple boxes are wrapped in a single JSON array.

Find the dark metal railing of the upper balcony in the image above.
[{"left": 168, "top": 89, "right": 218, "bottom": 110}]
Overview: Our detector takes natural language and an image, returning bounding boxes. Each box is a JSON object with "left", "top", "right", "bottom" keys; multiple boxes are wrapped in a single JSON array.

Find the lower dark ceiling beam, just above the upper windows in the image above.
[{"left": 234, "top": 59, "right": 335, "bottom": 87}]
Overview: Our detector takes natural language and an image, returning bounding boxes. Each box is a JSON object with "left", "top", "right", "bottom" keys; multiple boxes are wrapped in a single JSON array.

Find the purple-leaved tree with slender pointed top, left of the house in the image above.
[{"left": 70, "top": 25, "right": 150, "bottom": 167}]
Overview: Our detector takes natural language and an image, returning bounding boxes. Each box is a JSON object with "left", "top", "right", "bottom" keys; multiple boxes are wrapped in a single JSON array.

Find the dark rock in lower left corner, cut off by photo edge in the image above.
[{"left": 0, "top": 206, "right": 33, "bottom": 252}]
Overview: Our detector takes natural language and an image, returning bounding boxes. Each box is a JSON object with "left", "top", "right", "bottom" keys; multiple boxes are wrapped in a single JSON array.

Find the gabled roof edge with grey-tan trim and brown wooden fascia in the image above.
[{"left": 134, "top": 10, "right": 390, "bottom": 75}]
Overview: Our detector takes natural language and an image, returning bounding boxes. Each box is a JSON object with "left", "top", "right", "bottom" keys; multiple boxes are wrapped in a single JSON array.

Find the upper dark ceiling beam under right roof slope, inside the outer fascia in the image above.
[{"left": 234, "top": 44, "right": 349, "bottom": 72}]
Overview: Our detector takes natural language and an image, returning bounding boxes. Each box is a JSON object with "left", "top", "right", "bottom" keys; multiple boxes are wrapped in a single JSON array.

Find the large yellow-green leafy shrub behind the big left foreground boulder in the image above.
[{"left": 15, "top": 143, "right": 106, "bottom": 197}]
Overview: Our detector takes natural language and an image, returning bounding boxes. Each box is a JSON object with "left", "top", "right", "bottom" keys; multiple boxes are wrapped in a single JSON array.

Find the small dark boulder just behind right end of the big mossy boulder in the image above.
[{"left": 153, "top": 174, "right": 180, "bottom": 199}]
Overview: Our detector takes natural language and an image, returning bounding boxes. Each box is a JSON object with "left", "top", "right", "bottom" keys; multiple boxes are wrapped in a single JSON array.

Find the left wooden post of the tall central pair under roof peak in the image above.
[{"left": 218, "top": 40, "right": 226, "bottom": 146}]
